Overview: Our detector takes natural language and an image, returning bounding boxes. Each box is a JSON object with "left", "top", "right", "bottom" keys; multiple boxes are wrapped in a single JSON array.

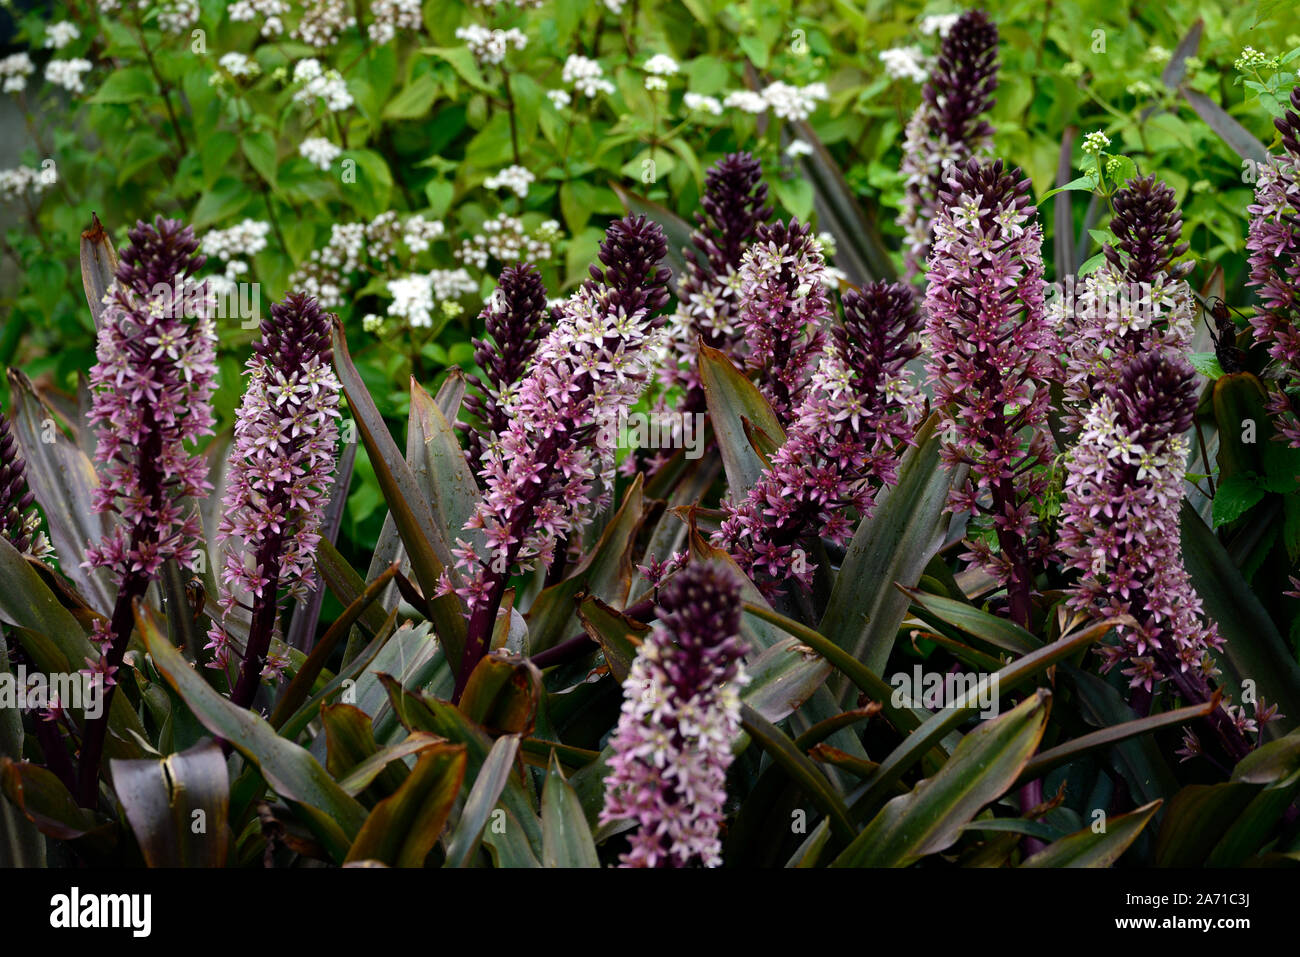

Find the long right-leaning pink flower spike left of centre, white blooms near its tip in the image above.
[{"left": 443, "top": 216, "right": 671, "bottom": 696}]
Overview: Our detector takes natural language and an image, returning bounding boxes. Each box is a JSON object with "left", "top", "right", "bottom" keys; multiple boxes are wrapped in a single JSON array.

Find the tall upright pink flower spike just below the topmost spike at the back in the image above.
[{"left": 924, "top": 159, "right": 1056, "bottom": 627}]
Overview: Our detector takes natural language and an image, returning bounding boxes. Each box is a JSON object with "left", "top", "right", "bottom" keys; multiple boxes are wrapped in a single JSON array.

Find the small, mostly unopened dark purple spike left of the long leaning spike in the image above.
[{"left": 460, "top": 263, "right": 551, "bottom": 472}]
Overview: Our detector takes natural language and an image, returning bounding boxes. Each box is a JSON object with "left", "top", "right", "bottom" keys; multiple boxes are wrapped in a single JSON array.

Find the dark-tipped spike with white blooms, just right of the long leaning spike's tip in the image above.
[{"left": 663, "top": 152, "right": 772, "bottom": 413}]
